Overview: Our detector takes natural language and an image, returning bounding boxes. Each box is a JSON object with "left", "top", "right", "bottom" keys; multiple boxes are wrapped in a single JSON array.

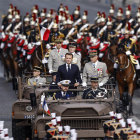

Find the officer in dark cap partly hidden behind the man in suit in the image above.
[{"left": 68, "top": 42, "right": 81, "bottom": 70}]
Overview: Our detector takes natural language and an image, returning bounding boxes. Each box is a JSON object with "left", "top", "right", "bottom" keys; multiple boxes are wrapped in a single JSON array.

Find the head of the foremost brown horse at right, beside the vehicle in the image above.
[{"left": 117, "top": 51, "right": 128, "bottom": 70}]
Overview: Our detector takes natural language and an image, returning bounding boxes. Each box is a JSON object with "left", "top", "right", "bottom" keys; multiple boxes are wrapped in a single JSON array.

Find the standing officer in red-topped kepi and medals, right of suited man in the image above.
[{"left": 82, "top": 50, "right": 109, "bottom": 87}]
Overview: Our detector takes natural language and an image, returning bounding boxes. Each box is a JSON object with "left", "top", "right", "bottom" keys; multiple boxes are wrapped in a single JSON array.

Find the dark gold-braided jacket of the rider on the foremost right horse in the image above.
[{"left": 118, "top": 38, "right": 137, "bottom": 54}]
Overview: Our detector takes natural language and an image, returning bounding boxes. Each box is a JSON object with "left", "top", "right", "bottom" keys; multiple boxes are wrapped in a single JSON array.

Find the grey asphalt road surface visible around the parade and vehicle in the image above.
[{"left": 0, "top": 0, "right": 140, "bottom": 136}]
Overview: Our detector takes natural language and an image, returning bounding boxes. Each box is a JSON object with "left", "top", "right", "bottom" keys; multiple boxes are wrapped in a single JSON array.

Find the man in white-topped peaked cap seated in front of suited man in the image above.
[{"left": 53, "top": 80, "right": 75, "bottom": 100}]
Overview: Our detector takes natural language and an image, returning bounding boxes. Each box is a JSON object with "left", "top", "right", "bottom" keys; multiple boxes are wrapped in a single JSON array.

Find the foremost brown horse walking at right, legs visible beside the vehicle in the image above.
[{"left": 116, "top": 51, "right": 136, "bottom": 115}]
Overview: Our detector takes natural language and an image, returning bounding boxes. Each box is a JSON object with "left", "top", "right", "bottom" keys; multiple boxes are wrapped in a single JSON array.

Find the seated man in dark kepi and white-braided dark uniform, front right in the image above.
[{"left": 82, "top": 76, "right": 107, "bottom": 99}]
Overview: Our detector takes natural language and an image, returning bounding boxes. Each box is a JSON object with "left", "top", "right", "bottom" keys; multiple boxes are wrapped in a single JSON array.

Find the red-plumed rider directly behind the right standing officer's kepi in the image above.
[{"left": 99, "top": 17, "right": 118, "bottom": 61}]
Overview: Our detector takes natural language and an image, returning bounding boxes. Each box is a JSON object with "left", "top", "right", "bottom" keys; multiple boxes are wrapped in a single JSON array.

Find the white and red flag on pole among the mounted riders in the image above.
[{"left": 40, "top": 27, "right": 50, "bottom": 41}]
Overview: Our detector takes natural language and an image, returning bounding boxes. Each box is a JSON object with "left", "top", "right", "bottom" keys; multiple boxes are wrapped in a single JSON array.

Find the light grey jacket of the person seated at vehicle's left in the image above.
[{"left": 28, "top": 77, "right": 46, "bottom": 85}]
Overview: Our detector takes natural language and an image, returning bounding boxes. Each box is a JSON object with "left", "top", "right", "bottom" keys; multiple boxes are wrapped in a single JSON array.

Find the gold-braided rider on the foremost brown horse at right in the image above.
[{"left": 110, "top": 23, "right": 140, "bottom": 84}]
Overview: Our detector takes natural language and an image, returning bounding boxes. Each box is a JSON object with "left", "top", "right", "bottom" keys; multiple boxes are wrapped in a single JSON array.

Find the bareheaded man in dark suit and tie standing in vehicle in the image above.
[{"left": 56, "top": 53, "right": 82, "bottom": 94}]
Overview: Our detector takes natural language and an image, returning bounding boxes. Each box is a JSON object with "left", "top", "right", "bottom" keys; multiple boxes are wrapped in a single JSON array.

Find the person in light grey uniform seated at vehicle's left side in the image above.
[{"left": 28, "top": 66, "right": 46, "bottom": 85}]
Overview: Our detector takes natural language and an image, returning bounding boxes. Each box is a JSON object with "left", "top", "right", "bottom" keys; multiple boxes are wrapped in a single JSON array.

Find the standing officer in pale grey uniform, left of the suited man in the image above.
[{"left": 48, "top": 38, "right": 68, "bottom": 73}]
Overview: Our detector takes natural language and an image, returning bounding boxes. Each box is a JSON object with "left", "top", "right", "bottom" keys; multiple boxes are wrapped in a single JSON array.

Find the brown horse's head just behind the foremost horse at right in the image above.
[{"left": 108, "top": 44, "right": 118, "bottom": 63}]
